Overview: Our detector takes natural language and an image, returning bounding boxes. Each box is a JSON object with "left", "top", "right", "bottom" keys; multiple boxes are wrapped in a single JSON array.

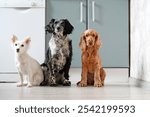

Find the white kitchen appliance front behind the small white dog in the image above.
[{"left": 0, "top": 0, "right": 45, "bottom": 74}]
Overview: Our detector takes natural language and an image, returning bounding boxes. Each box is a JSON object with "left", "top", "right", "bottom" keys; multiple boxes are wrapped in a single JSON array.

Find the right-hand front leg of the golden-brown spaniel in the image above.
[{"left": 94, "top": 65, "right": 102, "bottom": 87}]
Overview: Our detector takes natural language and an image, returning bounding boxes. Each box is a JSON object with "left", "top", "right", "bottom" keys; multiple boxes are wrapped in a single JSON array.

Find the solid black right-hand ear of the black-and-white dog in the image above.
[{"left": 63, "top": 19, "right": 74, "bottom": 35}]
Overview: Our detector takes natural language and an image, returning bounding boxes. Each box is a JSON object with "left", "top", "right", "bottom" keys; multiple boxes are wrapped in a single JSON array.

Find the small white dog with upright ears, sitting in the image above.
[{"left": 11, "top": 35, "right": 44, "bottom": 87}]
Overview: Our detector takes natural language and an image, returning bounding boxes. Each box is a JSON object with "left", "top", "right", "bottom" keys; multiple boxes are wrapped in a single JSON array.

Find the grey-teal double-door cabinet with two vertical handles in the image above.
[{"left": 46, "top": 0, "right": 129, "bottom": 67}]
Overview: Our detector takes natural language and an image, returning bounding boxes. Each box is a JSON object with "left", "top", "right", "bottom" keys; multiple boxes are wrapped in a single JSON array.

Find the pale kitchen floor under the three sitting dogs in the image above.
[{"left": 0, "top": 68, "right": 150, "bottom": 100}]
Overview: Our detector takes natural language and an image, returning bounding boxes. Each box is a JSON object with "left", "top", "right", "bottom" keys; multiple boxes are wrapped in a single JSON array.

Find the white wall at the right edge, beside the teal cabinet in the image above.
[{"left": 131, "top": 0, "right": 150, "bottom": 81}]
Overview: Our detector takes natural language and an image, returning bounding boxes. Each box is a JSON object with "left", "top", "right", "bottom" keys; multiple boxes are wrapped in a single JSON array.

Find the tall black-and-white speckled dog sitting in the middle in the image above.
[{"left": 41, "top": 19, "right": 74, "bottom": 86}]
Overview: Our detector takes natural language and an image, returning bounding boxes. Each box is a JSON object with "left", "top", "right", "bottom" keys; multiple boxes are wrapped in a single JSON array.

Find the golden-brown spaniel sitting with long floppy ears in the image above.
[{"left": 77, "top": 29, "right": 106, "bottom": 87}]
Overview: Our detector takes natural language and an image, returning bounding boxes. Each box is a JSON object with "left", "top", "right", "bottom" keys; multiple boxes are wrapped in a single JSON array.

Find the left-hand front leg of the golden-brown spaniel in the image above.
[{"left": 77, "top": 65, "right": 88, "bottom": 87}]
